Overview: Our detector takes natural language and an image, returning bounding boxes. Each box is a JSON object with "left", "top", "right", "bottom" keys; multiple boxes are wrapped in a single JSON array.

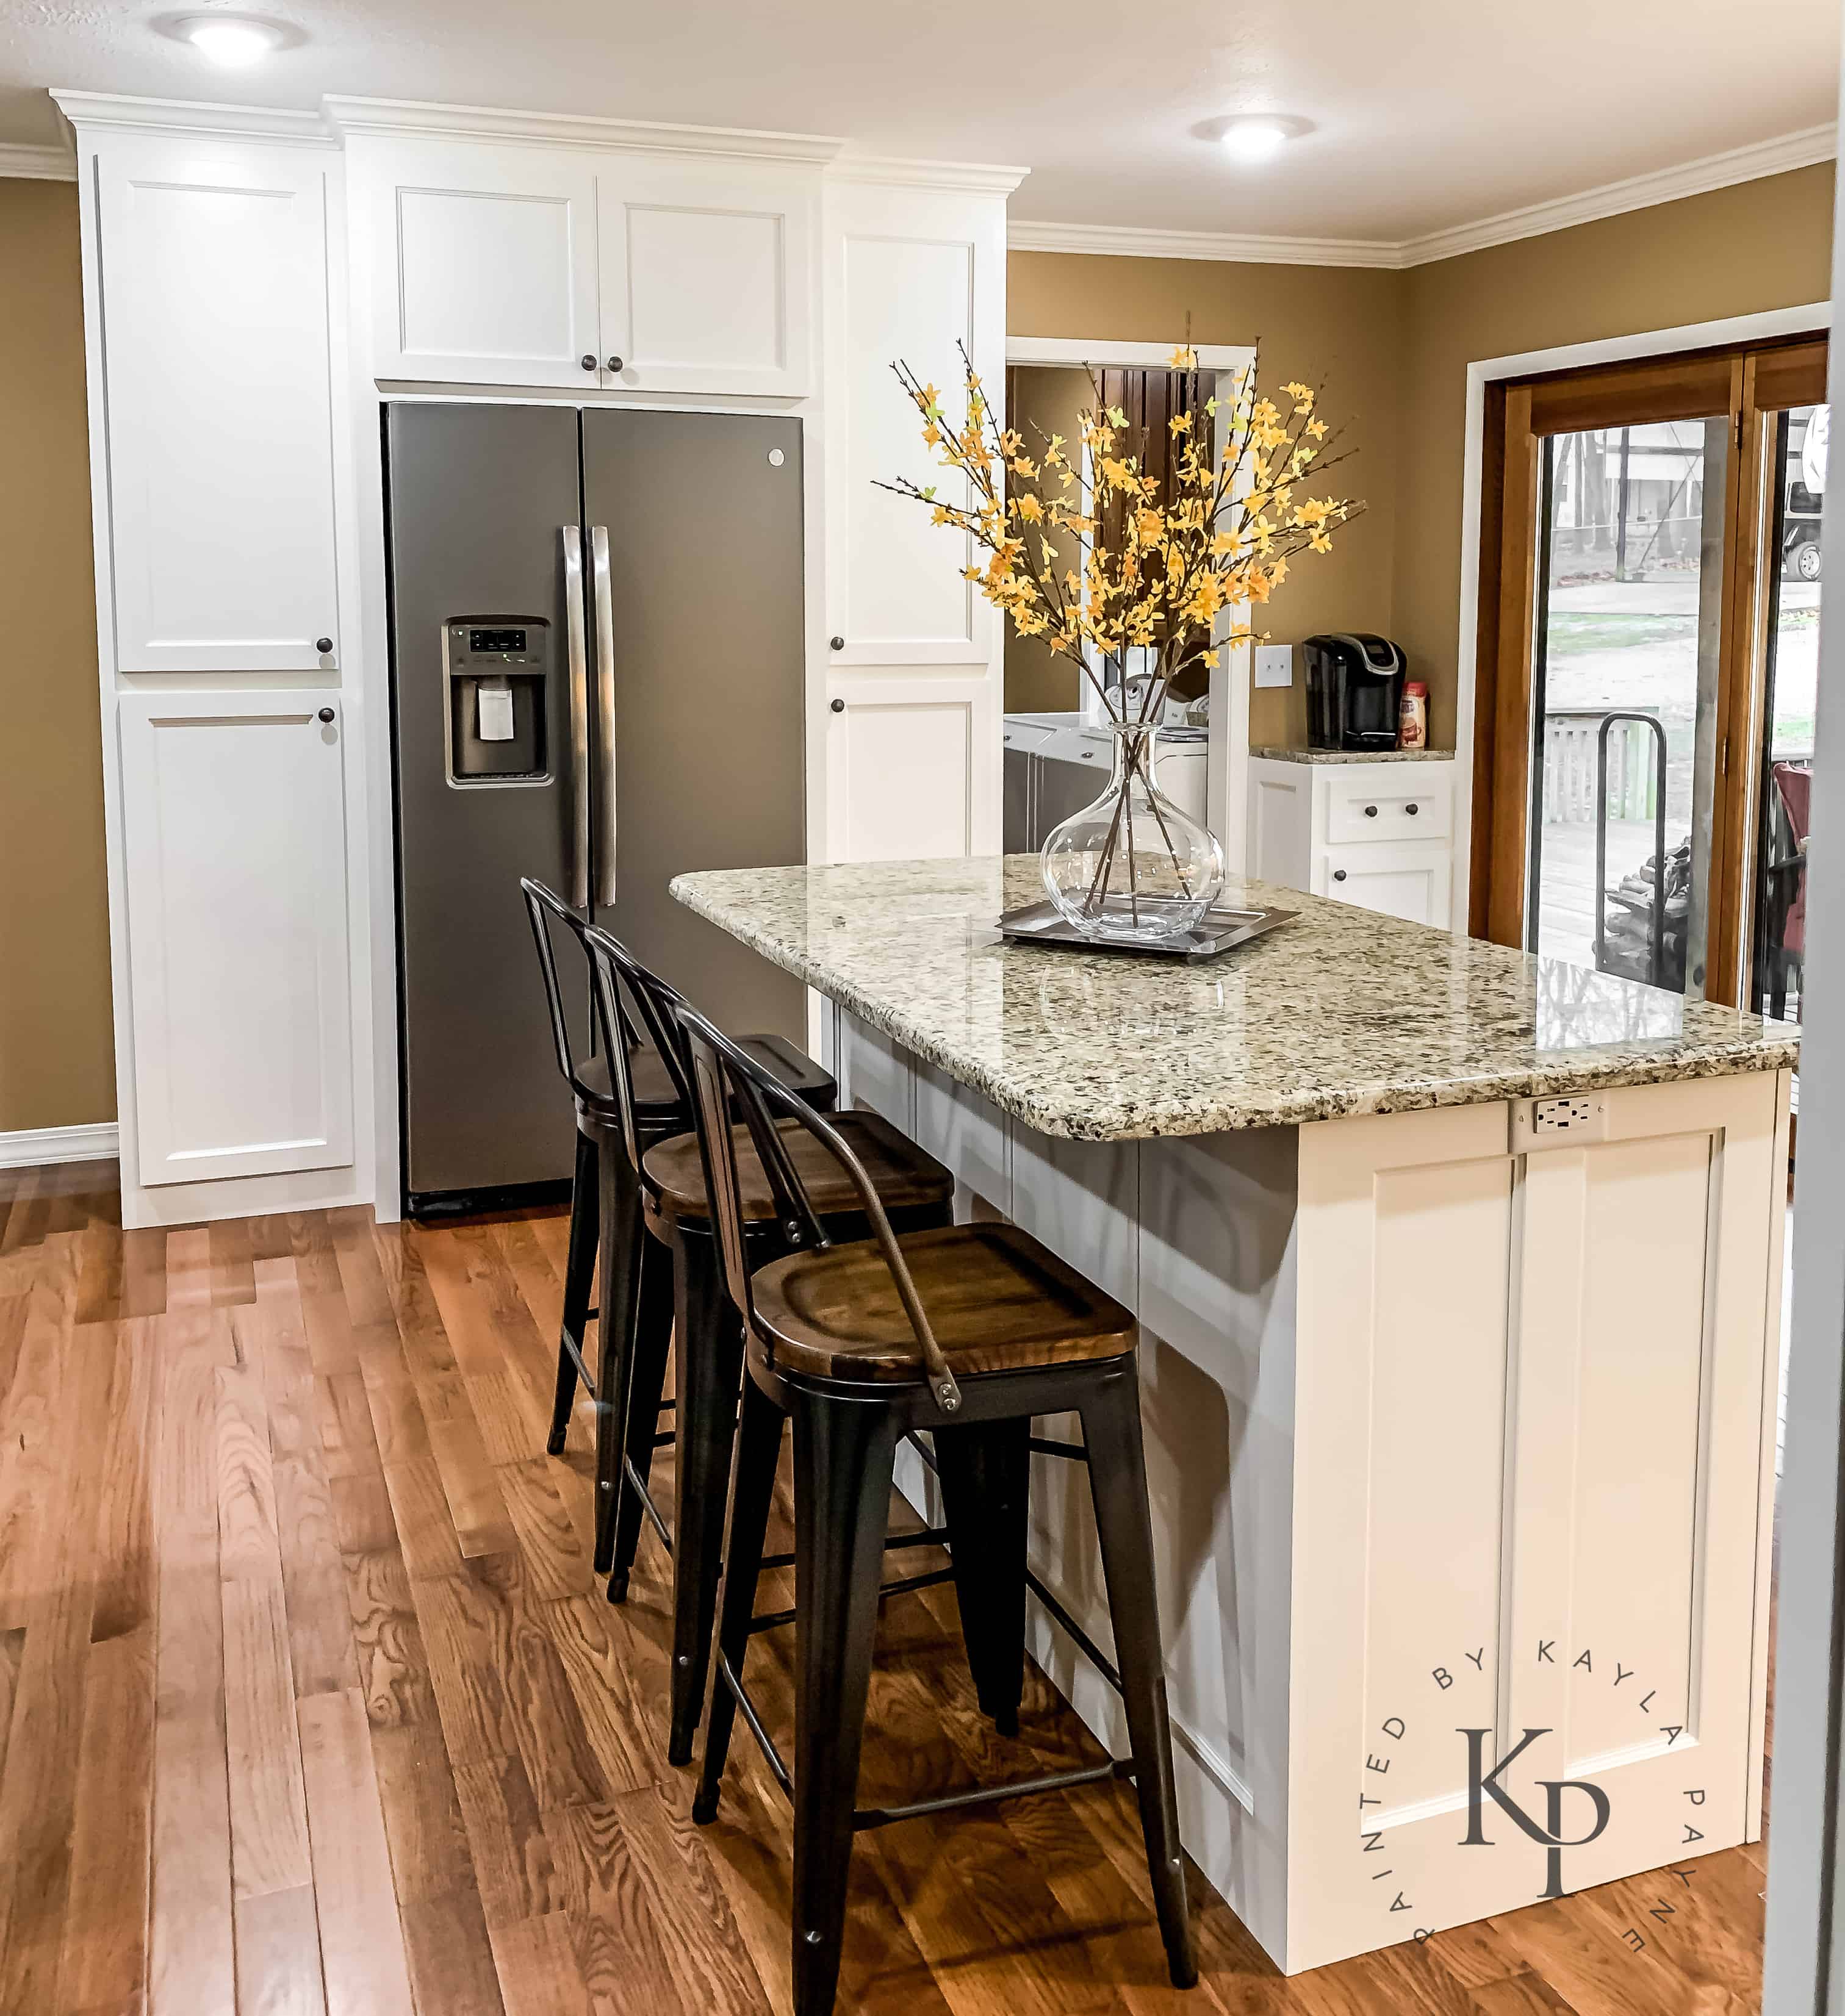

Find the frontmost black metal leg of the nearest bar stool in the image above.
[{"left": 794, "top": 1393, "right": 897, "bottom": 2016}]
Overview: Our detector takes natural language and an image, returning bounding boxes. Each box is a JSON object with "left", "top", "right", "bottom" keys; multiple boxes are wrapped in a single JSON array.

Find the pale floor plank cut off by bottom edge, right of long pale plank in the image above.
[{"left": 297, "top": 1687, "right": 414, "bottom": 2016}]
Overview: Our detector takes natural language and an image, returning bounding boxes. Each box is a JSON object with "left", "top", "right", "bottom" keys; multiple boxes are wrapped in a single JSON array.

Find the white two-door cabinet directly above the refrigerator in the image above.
[{"left": 351, "top": 130, "right": 819, "bottom": 397}]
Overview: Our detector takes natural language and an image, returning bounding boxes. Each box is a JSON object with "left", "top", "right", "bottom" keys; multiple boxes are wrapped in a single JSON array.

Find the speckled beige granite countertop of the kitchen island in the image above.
[{"left": 672, "top": 855, "right": 1799, "bottom": 1141}]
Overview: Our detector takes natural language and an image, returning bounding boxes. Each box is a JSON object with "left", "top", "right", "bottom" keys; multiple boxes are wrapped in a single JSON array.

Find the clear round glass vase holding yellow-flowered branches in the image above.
[{"left": 1043, "top": 722, "right": 1224, "bottom": 941}]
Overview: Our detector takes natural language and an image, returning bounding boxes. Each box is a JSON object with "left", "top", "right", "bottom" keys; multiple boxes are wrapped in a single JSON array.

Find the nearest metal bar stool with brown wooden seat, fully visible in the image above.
[{"left": 680, "top": 1010, "right": 1198, "bottom": 2016}]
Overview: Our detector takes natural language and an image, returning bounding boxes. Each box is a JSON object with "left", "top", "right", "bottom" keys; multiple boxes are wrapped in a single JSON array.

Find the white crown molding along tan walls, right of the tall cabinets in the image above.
[{"left": 1006, "top": 125, "right": 1839, "bottom": 272}]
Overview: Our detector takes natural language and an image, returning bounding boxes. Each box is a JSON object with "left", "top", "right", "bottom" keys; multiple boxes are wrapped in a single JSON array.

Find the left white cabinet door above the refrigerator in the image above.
[{"left": 351, "top": 139, "right": 601, "bottom": 387}]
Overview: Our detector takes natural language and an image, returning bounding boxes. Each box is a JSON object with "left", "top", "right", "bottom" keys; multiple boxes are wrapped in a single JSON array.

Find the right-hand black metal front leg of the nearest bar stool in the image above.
[{"left": 1081, "top": 1359, "right": 1198, "bottom": 1988}]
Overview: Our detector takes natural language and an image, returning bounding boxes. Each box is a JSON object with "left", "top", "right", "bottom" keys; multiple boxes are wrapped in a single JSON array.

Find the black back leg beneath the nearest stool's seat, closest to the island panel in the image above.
[{"left": 935, "top": 1419, "right": 1030, "bottom": 1736}]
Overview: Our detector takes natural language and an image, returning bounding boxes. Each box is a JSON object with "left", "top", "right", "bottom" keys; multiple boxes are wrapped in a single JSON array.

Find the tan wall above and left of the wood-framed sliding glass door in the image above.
[{"left": 1391, "top": 161, "right": 1835, "bottom": 746}]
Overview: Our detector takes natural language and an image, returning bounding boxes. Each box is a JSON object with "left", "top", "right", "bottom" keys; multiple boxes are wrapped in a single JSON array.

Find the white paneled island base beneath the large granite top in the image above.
[{"left": 835, "top": 1010, "right": 1788, "bottom": 1974}]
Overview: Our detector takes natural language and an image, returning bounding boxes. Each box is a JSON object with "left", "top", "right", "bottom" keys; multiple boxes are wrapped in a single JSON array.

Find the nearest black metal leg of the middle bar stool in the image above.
[{"left": 666, "top": 1232, "right": 744, "bottom": 1764}]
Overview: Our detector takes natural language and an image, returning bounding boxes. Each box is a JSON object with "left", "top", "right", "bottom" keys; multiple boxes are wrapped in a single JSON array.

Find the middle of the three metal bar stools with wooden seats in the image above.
[{"left": 584, "top": 927, "right": 960, "bottom": 1764}]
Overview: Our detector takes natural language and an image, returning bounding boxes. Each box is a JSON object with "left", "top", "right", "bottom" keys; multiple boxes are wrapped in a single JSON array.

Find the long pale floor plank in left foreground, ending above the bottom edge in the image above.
[{"left": 218, "top": 1365, "right": 312, "bottom": 1897}]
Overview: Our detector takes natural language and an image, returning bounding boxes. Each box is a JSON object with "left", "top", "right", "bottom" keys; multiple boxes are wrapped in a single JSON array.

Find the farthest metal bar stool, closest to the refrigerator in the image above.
[{"left": 518, "top": 879, "right": 837, "bottom": 1574}]
